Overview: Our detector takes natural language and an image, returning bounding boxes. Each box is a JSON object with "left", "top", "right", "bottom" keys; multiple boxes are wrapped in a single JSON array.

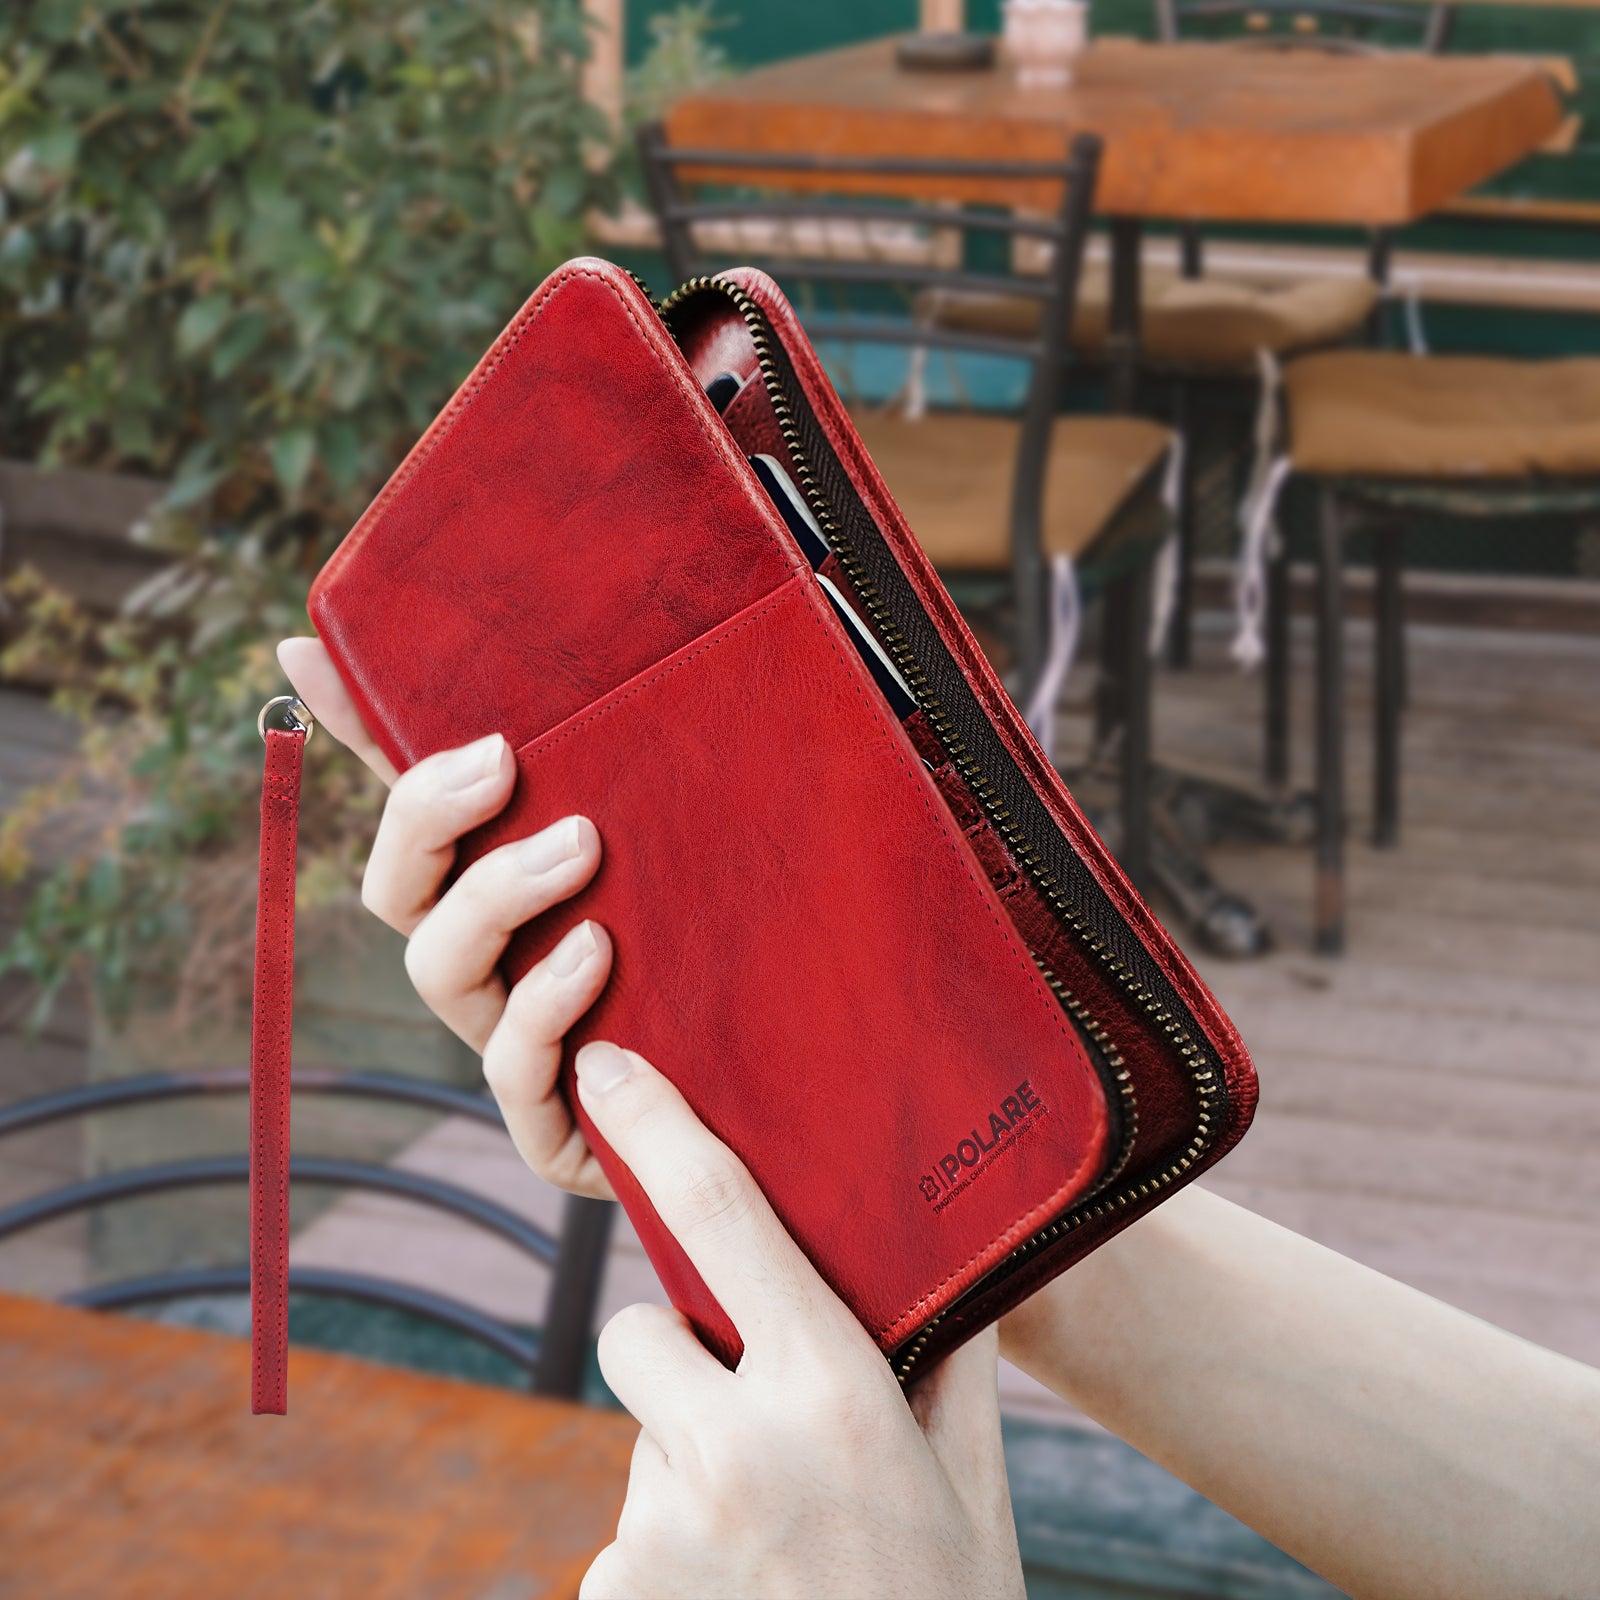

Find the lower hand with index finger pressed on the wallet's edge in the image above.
[{"left": 578, "top": 1042, "right": 1022, "bottom": 1600}]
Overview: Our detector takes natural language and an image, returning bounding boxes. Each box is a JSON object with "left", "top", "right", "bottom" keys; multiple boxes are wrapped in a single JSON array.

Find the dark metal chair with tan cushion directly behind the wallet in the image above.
[{"left": 638, "top": 125, "right": 1171, "bottom": 902}]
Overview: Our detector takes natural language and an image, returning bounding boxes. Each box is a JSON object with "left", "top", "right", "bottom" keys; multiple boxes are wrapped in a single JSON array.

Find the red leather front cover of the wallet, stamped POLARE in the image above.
[{"left": 312, "top": 262, "right": 1109, "bottom": 1360}]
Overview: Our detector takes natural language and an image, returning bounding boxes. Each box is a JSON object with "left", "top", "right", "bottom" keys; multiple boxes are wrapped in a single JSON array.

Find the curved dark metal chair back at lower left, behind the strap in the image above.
[{"left": 0, "top": 1067, "right": 616, "bottom": 1398}]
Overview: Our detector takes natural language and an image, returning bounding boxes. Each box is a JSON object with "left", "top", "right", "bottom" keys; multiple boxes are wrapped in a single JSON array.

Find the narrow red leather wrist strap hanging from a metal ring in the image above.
[{"left": 250, "top": 728, "right": 306, "bottom": 1416}]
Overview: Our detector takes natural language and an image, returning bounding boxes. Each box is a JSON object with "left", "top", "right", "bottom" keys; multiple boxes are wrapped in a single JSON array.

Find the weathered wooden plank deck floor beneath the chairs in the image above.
[{"left": 0, "top": 601, "right": 1600, "bottom": 1416}]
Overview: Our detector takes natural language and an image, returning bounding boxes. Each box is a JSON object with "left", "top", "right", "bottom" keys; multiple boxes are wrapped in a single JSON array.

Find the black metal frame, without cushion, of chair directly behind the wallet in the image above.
[{"left": 637, "top": 123, "right": 1177, "bottom": 902}]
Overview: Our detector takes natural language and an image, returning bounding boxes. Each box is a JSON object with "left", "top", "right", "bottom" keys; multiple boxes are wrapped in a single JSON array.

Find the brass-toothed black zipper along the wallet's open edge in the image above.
[{"left": 658, "top": 277, "right": 1222, "bottom": 1384}]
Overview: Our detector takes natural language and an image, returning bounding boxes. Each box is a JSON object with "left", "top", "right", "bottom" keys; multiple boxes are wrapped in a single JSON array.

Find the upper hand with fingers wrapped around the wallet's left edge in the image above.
[{"left": 278, "top": 638, "right": 611, "bottom": 1198}]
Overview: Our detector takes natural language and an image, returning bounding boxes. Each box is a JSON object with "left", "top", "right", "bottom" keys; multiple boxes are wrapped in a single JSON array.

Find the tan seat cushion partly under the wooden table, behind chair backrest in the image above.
[{"left": 918, "top": 264, "right": 1378, "bottom": 374}]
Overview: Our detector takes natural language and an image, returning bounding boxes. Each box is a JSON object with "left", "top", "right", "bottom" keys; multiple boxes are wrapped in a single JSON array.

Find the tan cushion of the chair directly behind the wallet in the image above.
[{"left": 853, "top": 410, "right": 1173, "bottom": 573}]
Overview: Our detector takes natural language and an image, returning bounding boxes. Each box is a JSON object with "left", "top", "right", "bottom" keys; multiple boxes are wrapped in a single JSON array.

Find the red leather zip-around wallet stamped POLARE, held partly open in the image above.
[{"left": 252, "top": 259, "right": 1256, "bottom": 1408}]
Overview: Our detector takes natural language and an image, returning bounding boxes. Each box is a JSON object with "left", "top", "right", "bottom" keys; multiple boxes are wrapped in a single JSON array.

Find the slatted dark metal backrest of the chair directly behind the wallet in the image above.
[{"left": 638, "top": 123, "right": 1101, "bottom": 670}]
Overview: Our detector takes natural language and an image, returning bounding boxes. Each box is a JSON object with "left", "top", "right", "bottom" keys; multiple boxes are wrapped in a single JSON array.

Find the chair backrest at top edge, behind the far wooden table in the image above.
[{"left": 1155, "top": 0, "right": 1454, "bottom": 53}]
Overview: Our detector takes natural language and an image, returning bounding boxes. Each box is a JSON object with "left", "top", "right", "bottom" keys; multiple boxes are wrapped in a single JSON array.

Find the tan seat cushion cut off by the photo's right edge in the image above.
[{"left": 1285, "top": 350, "right": 1600, "bottom": 480}]
